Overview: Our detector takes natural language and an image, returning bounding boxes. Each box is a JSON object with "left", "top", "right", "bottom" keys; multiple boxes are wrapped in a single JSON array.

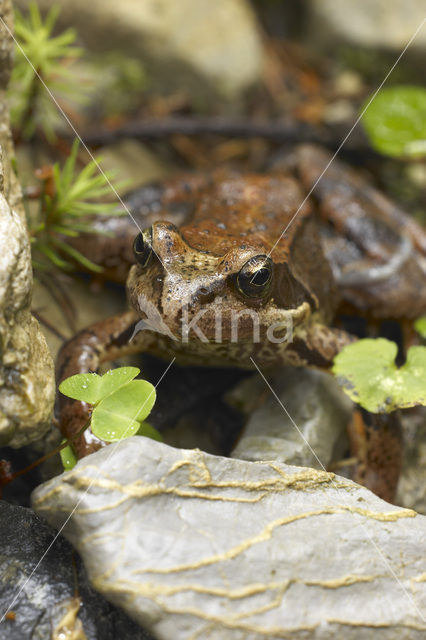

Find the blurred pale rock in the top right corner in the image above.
[{"left": 308, "top": 0, "right": 426, "bottom": 50}]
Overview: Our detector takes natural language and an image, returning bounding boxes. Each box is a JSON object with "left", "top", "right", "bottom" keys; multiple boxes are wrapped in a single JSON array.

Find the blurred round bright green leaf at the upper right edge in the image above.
[{"left": 362, "top": 86, "right": 426, "bottom": 157}]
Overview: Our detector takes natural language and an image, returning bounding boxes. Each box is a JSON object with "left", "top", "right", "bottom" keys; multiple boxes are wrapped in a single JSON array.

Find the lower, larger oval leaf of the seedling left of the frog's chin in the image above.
[{"left": 91, "top": 380, "right": 156, "bottom": 442}]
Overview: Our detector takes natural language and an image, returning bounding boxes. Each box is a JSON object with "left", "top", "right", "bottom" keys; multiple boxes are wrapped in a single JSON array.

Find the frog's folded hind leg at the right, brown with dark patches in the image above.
[{"left": 294, "top": 145, "right": 426, "bottom": 319}]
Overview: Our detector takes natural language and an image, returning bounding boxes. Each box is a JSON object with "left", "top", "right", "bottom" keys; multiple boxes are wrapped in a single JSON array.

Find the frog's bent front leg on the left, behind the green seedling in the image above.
[{"left": 56, "top": 311, "right": 153, "bottom": 458}]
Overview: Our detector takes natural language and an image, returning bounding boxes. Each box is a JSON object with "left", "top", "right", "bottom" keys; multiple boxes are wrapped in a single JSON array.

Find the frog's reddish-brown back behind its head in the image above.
[{"left": 180, "top": 172, "right": 337, "bottom": 319}]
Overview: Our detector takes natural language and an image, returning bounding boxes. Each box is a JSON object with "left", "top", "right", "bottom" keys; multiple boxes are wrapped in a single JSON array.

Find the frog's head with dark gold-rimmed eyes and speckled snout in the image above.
[{"left": 127, "top": 222, "right": 313, "bottom": 344}]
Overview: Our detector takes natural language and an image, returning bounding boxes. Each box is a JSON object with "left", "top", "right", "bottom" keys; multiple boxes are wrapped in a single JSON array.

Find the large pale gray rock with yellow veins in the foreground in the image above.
[{"left": 33, "top": 437, "right": 426, "bottom": 640}]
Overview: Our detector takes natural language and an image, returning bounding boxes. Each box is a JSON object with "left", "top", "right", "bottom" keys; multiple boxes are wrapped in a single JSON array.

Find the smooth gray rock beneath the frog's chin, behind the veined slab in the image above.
[{"left": 229, "top": 367, "right": 353, "bottom": 469}]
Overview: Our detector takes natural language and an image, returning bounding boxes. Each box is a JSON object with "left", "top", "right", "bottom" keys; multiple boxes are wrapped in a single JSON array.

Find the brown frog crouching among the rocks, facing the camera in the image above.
[{"left": 58, "top": 145, "right": 426, "bottom": 500}]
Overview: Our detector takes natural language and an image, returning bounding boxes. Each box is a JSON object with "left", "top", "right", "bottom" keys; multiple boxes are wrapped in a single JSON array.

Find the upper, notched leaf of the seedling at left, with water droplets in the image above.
[{"left": 59, "top": 367, "right": 140, "bottom": 404}]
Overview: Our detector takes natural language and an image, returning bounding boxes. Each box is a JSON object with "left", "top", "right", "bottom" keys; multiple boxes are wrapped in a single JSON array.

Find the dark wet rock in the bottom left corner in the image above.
[{"left": 0, "top": 502, "right": 152, "bottom": 640}]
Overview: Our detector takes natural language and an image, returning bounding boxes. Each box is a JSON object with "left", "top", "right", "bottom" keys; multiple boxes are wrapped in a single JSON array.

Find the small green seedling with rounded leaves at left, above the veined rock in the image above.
[{"left": 59, "top": 367, "right": 162, "bottom": 469}]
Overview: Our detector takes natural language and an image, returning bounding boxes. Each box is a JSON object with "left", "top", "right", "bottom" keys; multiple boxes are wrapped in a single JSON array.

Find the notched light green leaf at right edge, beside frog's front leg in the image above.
[{"left": 332, "top": 338, "right": 426, "bottom": 413}]
